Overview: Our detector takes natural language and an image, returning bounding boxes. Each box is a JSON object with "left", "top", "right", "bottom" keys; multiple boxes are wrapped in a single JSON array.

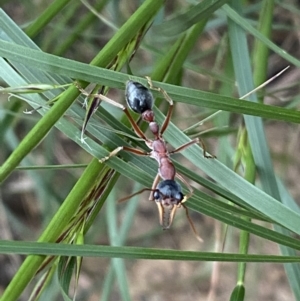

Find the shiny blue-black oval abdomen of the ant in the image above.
[{"left": 125, "top": 80, "right": 154, "bottom": 114}]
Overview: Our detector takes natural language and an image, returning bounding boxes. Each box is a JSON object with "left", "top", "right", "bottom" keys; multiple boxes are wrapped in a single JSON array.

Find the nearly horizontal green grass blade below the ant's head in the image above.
[{"left": 0, "top": 241, "right": 300, "bottom": 263}]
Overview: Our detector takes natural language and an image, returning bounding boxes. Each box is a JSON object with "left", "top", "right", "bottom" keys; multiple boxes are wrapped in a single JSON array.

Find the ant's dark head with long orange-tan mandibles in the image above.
[{"left": 153, "top": 180, "right": 185, "bottom": 229}]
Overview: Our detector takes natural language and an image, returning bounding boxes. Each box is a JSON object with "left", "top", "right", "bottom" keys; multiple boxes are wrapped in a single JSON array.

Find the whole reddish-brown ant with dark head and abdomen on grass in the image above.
[{"left": 78, "top": 77, "right": 215, "bottom": 241}]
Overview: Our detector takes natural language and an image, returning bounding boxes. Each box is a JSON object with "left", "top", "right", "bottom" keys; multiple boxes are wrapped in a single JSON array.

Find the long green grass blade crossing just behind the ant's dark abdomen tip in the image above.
[{"left": 0, "top": 41, "right": 300, "bottom": 123}]
